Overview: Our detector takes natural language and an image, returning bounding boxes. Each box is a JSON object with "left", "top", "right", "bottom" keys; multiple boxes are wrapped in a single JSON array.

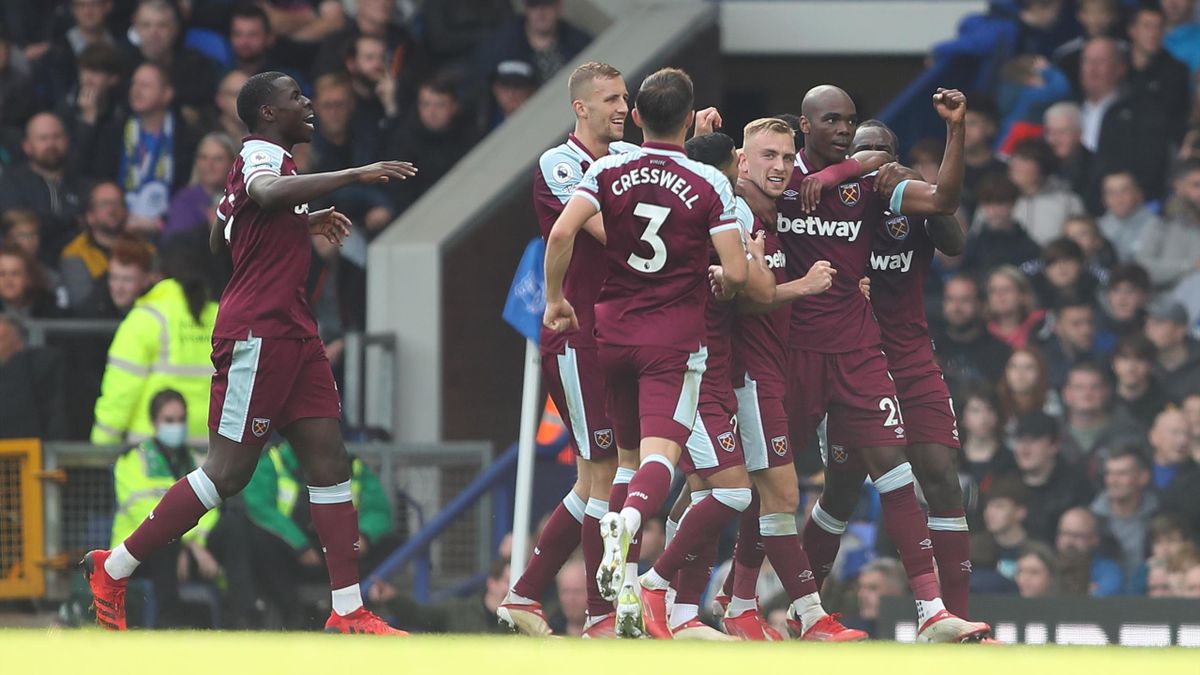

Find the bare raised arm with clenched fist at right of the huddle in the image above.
[{"left": 890, "top": 89, "right": 967, "bottom": 216}]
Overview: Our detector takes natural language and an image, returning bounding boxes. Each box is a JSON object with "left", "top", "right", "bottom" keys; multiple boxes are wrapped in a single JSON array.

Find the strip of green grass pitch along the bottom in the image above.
[{"left": 0, "top": 629, "right": 1200, "bottom": 675}]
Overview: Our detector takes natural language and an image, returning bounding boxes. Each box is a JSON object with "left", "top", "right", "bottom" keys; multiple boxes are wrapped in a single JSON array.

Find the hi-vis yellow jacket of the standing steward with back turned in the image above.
[{"left": 91, "top": 279, "right": 217, "bottom": 446}]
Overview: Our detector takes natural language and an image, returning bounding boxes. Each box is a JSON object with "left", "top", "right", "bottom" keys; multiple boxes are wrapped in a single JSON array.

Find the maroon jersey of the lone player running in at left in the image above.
[{"left": 212, "top": 136, "right": 317, "bottom": 340}]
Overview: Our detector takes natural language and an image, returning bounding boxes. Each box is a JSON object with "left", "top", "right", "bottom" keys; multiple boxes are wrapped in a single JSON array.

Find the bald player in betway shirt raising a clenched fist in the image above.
[{"left": 778, "top": 85, "right": 990, "bottom": 641}]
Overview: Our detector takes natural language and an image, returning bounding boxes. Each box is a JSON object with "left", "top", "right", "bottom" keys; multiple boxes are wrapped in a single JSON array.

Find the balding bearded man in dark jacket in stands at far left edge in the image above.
[{"left": 0, "top": 113, "right": 83, "bottom": 264}]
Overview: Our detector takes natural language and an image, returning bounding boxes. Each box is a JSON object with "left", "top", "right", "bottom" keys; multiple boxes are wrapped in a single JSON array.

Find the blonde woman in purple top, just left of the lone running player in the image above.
[{"left": 162, "top": 131, "right": 238, "bottom": 243}]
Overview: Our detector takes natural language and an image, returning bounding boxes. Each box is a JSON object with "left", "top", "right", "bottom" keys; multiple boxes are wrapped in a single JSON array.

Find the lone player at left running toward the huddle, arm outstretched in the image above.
[{"left": 80, "top": 72, "right": 416, "bottom": 634}]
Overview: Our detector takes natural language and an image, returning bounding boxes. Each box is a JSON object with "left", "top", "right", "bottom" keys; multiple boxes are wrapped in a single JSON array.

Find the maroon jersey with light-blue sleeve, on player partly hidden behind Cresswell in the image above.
[{"left": 533, "top": 133, "right": 637, "bottom": 353}]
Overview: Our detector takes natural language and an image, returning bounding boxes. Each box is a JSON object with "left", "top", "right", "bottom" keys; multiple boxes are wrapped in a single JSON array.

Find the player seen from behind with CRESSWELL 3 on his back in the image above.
[{"left": 545, "top": 68, "right": 750, "bottom": 637}]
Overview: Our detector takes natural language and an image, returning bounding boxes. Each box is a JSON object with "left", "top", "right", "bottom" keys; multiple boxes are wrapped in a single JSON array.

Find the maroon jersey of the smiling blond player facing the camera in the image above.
[{"left": 733, "top": 192, "right": 792, "bottom": 398}]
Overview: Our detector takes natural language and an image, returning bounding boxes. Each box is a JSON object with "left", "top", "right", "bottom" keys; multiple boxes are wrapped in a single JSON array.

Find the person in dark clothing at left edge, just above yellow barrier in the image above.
[{"left": 0, "top": 312, "right": 66, "bottom": 440}]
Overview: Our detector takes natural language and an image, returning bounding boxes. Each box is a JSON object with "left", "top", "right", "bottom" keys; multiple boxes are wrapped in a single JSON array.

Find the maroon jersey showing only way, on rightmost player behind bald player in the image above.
[{"left": 870, "top": 211, "right": 934, "bottom": 370}]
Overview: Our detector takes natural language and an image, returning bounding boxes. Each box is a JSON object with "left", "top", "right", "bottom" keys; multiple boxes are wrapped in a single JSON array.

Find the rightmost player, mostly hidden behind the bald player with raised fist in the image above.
[{"left": 818, "top": 120, "right": 971, "bottom": 617}]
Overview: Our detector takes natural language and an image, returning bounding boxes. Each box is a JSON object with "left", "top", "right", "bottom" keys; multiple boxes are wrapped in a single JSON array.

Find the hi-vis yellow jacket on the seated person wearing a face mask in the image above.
[{"left": 110, "top": 438, "right": 220, "bottom": 548}]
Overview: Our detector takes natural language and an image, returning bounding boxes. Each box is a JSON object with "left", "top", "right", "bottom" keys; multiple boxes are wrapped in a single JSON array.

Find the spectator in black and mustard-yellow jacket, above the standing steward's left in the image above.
[{"left": 59, "top": 180, "right": 128, "bottom": 309}]
